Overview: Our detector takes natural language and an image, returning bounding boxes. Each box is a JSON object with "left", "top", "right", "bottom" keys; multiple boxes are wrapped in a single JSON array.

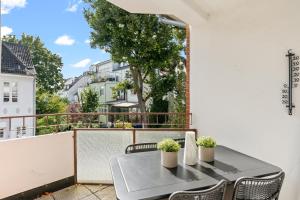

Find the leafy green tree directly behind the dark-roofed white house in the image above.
[{"left": 3, "top": 33, "right": 64, "bottom": 94}]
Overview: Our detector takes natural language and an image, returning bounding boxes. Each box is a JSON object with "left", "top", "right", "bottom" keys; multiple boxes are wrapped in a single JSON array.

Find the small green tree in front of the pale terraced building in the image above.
[{"left": 80, "top": 87, "right": 99, "bottom": 113}]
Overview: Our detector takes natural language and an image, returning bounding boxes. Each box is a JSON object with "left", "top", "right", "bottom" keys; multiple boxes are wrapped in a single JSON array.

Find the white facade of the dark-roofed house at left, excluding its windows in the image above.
[{"left": 0, "top": 73, "right": 35, "bottom": 139}]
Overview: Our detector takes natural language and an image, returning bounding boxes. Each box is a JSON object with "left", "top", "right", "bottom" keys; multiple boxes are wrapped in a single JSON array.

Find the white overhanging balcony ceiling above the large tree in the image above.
[{"left": 108, "top": 0, "right": 251, "bottom": 25}]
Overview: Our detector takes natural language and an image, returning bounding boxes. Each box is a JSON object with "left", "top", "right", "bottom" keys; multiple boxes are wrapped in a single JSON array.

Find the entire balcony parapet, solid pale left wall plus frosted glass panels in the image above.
[{"left": 0, "top": 128, "right": 197, "bottom": 199}]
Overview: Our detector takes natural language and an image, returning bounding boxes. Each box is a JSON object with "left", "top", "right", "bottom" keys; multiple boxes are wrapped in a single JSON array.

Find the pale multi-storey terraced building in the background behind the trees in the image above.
[{"left": 58, "top": 60, "right": 137, "bottom": 112}]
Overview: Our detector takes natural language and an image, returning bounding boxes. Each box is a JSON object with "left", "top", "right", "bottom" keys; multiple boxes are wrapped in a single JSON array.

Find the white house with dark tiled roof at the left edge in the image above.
[{"left": 0, "top": 42, "right": 36, "bottom": 139}]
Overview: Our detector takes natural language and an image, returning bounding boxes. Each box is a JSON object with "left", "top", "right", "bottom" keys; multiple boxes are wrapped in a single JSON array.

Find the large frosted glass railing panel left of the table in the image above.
[{"left": 76, "top": 129, "right": 133, "bottom": 183}]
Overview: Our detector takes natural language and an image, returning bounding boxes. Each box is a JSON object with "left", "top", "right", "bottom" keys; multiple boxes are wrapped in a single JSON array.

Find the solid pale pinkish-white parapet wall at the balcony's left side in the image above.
[{"left": 0, "top": 132, "right": 74, "bottom": 199}]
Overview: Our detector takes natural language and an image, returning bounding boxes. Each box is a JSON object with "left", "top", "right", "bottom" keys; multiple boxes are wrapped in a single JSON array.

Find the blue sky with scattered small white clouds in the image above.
[{"left": 1, "top": 0, "right": 110, "bottom": 78}]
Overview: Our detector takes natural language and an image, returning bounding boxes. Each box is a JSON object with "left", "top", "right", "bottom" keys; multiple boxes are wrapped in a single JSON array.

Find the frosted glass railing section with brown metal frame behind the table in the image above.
[{"left": 74, "top": 128, "right": 197, "bottom": 184}]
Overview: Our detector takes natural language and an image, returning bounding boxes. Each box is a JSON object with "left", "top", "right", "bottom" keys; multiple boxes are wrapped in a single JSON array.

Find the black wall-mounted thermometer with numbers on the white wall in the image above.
[{"left": 282, "top": 49, "right": 299, "bottom": 115}]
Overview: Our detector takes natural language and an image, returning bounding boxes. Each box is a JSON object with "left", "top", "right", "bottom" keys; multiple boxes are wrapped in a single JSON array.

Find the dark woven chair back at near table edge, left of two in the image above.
[{"left": 169, "top": 180, "right": 226, "bottom": 200}]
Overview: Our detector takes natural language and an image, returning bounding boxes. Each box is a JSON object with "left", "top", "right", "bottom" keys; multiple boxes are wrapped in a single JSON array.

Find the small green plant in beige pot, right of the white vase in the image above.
[{"left": 197, "top": 136, "right": 217, "bottom": 162}]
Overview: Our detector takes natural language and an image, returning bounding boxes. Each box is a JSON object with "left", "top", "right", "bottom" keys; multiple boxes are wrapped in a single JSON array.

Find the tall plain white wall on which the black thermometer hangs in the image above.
[{"left": 191, "top": 0, "right": 300, "bottom": 200}]
